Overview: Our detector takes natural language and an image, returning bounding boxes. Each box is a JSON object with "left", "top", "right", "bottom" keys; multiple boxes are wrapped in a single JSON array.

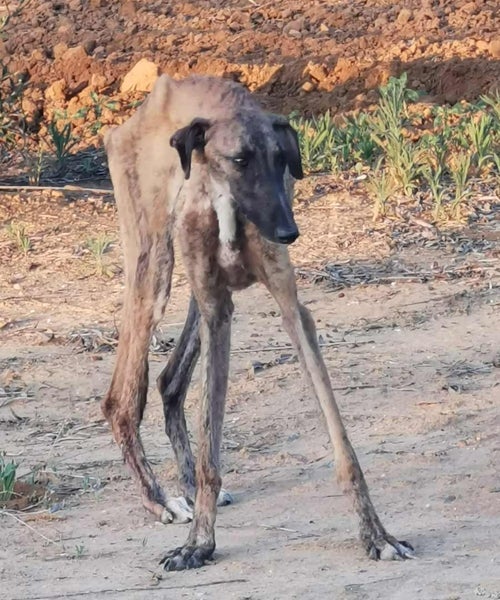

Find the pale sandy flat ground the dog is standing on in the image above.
[{"left": 0, "top": 181, "right": 500, "bottom": 600}]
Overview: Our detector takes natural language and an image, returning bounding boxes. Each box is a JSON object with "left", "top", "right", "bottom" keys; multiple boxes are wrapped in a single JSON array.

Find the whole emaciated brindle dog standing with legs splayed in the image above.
[{"left": 102, "top": 76, "right": 412, "bottom": 570}]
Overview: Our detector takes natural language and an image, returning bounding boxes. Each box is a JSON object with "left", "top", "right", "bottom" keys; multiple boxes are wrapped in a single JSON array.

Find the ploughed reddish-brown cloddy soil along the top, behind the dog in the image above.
[{"left": 0, "top": 0, "right": 500, "bottom": 120}]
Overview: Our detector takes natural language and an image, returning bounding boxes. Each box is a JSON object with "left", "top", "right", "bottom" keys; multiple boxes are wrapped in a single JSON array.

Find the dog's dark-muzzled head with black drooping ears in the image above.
[{"left": 170, "top": 110, "right": 303, "bottom": 244}]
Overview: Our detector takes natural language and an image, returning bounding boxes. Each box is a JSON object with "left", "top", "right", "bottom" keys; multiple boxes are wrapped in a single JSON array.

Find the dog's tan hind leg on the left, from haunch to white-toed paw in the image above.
[{"left": 102, "top": 96, "right": 191, "bottom": 522}]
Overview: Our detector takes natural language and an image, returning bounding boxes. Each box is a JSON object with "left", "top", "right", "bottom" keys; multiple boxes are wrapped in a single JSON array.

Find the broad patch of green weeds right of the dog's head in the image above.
[{"left": 291, "top": 74, "right": 500, "bottom": 220}]
